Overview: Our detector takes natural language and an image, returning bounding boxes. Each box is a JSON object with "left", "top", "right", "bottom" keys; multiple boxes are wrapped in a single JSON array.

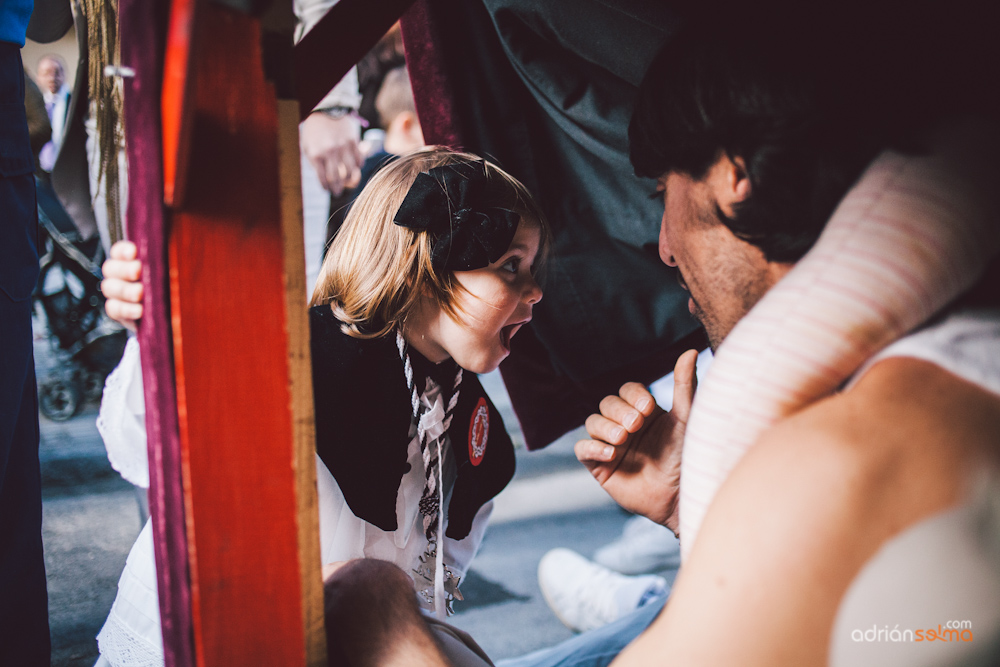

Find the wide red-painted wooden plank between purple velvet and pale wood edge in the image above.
[{"left": 170, "top": 3, "right": 306, "bottom": 666}]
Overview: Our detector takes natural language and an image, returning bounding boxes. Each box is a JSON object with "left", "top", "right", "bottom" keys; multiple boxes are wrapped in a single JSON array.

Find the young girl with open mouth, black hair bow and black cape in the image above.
[{"left": 98, "top": 148, "right": 548, "bottom": 666}]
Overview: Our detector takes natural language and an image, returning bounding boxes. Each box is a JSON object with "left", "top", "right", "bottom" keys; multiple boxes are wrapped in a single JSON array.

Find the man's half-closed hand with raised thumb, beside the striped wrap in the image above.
[{"left": 575, "top": 350, "right": 698, "bottom": 534}]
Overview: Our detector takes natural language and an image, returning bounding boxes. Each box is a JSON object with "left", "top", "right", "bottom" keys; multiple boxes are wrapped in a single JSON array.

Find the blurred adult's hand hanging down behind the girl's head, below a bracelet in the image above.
[{"left": 299, "top": 111, "right": 363, "bottom": 197}]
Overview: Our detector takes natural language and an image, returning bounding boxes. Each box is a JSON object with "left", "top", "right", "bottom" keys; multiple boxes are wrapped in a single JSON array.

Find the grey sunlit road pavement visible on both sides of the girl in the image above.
[{"left": 35, "top": 320, "right": 627, "bottom": 667}]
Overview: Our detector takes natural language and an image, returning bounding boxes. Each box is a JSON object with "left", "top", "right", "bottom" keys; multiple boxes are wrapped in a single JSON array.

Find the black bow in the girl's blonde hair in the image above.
[{"left": 393, "top": 161, "right": 520, "bottom": 273}]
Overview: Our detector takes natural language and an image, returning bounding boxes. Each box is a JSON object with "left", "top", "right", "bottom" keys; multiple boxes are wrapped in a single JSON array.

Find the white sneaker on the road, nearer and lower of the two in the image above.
[{"left": 538, "top": 549, "right": 667, "bottom": 632}]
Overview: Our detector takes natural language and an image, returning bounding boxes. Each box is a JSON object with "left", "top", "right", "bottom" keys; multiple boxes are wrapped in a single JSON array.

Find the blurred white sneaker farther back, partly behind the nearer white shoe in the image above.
[{"left": 594, "top": 516, "right": 681, "bottom": 574}]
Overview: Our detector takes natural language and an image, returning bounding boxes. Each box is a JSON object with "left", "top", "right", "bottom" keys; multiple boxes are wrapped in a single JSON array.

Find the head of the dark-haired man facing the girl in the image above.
[{"left": 629, "top": 18, "right": 888, "bottom": 348}]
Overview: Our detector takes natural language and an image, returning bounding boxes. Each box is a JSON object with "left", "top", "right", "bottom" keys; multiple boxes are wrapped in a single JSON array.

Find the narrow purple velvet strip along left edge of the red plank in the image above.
[{"left": 119, "top": 0, "right": 195, "bottom": 667}]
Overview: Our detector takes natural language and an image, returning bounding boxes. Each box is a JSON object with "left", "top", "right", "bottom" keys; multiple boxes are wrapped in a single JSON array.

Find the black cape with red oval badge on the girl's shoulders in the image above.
[{"left": 309, "top": 306, "right": 515, "bottom": 540}]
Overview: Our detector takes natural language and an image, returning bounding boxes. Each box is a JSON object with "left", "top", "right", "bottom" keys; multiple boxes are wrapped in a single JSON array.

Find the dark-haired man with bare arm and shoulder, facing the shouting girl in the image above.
[{"left": 577, "top": 15, "right": 1000, "bottom": 665}]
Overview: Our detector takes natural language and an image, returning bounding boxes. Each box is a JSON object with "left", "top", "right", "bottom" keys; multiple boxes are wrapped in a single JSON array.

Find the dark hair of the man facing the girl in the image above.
[{"left": 629, "top": 28, "right": 876, "bottom": 263}]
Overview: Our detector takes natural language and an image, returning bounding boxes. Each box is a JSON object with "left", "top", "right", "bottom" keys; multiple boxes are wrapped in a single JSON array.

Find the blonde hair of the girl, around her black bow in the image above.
[{"left": 309, "top": 146, "right": 549, "bottom": 338}]
